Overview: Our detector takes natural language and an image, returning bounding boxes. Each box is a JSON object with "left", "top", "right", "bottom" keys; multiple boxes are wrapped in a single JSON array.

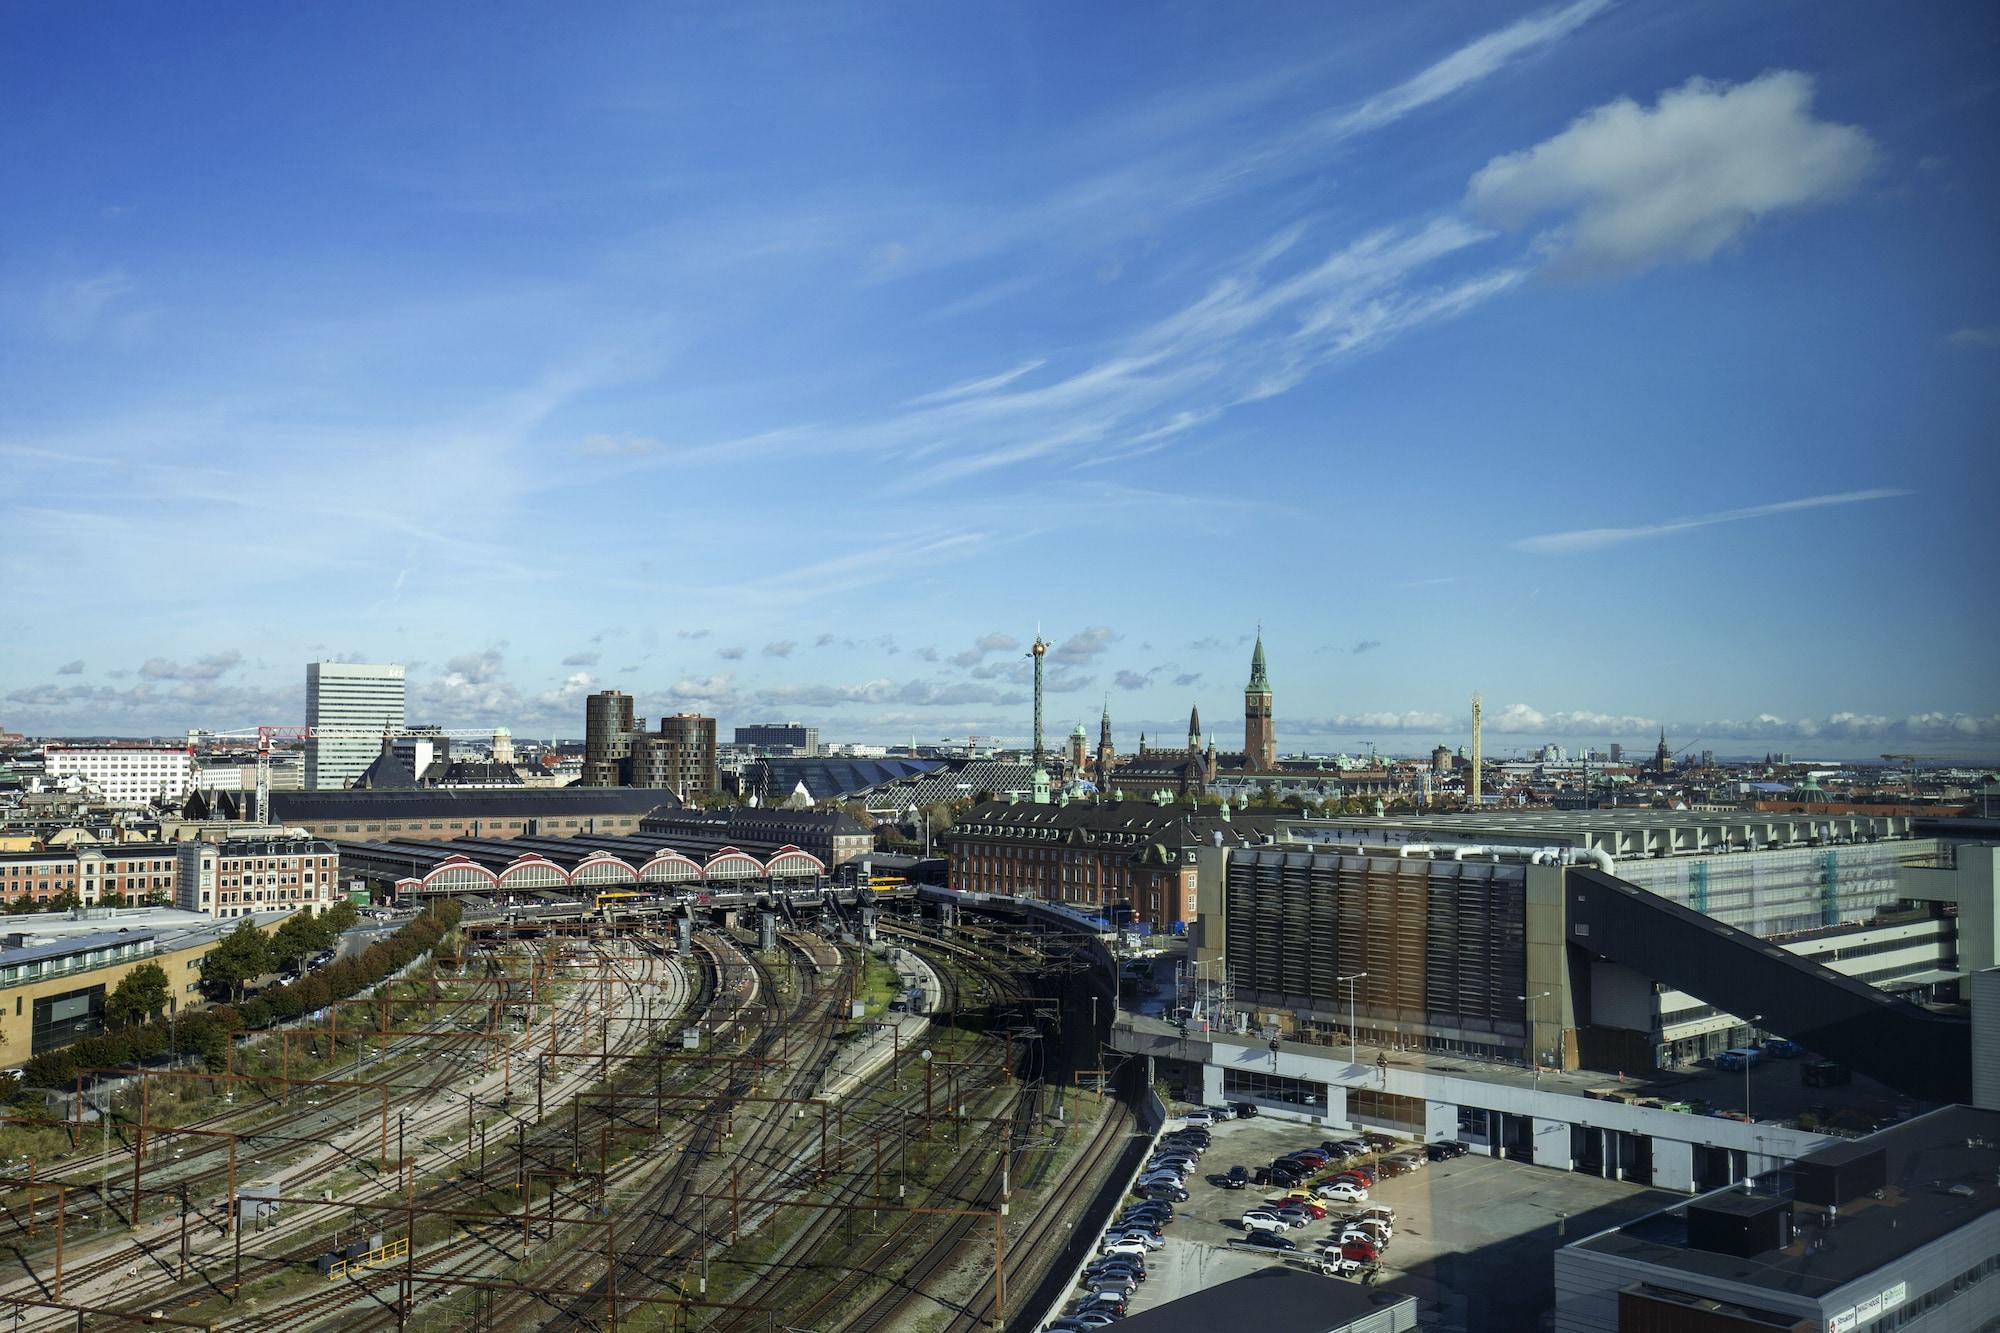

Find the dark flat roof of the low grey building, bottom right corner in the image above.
[{"left": 1576, "top": 1107, "right": 2000, "bottom": 1297}]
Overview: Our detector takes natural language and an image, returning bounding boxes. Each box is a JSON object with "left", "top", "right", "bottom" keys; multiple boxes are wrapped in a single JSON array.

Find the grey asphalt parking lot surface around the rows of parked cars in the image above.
[{"left": 1072, "top": 1117, "right": 1680, "bottom": 1333}]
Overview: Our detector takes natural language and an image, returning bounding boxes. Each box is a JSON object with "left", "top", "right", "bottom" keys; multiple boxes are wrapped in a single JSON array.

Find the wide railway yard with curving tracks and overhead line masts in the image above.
[{"left": 0, "top": 896, "right": 1142, "bottom": 1333}]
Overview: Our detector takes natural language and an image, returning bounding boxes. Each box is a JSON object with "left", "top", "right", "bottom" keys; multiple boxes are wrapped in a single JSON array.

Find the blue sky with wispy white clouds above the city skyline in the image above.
[{"left": 0, "top": 0, "right": 2000, "bottom": 757}]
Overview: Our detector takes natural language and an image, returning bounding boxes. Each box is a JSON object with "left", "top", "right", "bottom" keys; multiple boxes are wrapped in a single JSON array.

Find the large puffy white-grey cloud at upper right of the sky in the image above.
[{"left": 1466, "top": 70, "right": 1880, "bottom": 272}]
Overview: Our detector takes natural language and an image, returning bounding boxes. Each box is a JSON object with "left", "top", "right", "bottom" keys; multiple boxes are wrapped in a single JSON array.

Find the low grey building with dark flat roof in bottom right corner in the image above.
[{"left": 1554, "top": 1105, "right": 2000, "bottom": 1333}]
